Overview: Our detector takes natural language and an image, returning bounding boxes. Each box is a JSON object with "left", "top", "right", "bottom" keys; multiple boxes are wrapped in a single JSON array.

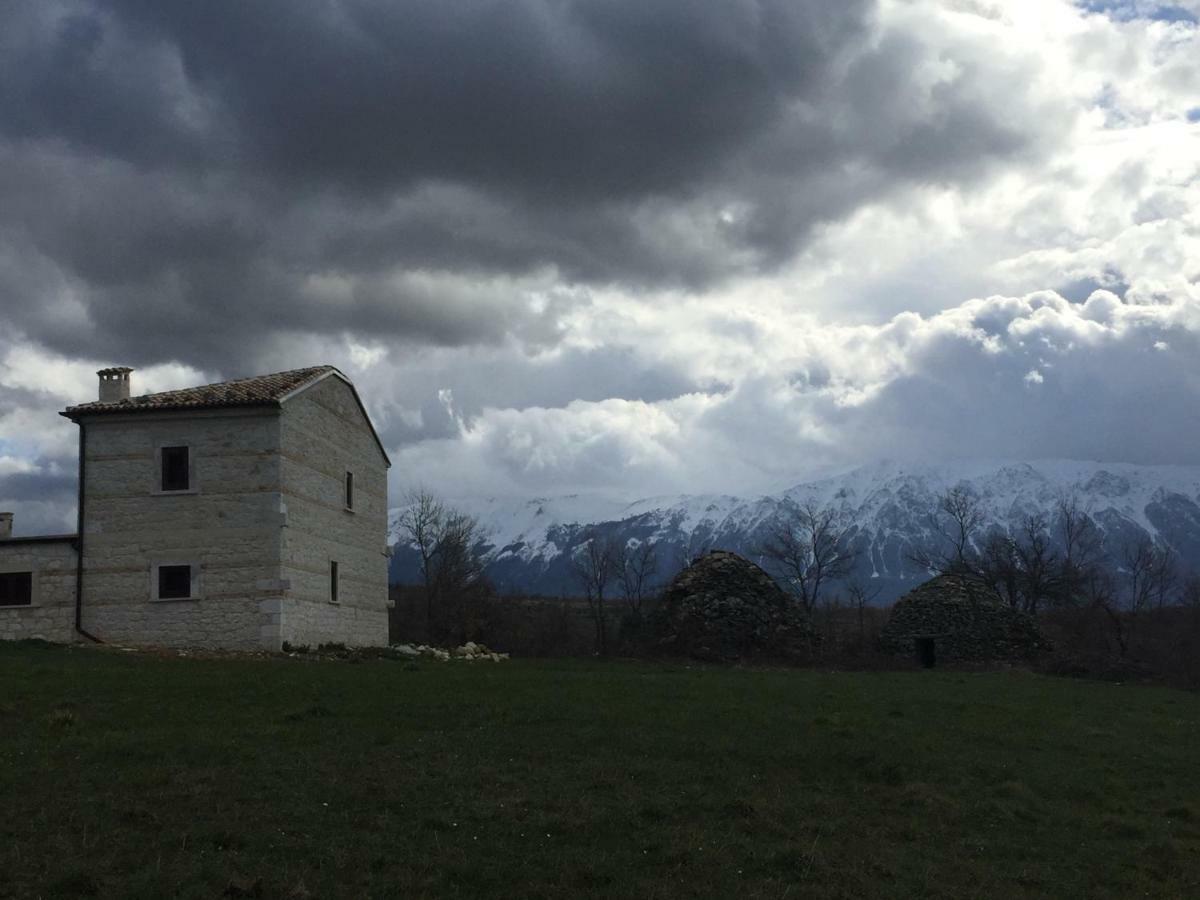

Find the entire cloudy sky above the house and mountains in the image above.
[{"left": 0, "top": 0, "right": 1200, "bottom": 533}]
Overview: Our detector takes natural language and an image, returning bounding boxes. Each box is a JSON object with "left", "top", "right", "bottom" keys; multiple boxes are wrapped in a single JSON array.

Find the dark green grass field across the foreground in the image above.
[{"left": 0, "top": 644, "right": 1200, "bottom": 898}]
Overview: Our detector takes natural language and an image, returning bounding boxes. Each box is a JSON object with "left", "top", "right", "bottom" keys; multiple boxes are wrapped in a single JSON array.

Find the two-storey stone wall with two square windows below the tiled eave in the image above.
[{"left": 83, "top": 408, "right": 283, "bottom": 649}]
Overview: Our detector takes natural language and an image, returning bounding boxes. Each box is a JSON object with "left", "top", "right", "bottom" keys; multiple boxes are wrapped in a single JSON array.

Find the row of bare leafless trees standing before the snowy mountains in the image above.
[{"left": 398, "top": 485, "right": 1200, "bottom": 654}]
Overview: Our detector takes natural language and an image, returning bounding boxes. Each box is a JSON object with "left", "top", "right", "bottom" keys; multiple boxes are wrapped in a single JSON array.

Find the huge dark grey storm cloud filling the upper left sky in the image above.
[{"left": 0, "top": 0, "right": 1052, "bottom": 372}]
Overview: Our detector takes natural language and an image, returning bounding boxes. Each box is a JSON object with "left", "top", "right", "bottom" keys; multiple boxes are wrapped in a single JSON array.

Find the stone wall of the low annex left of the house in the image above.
[{"left": 0, "top": 540, "right": 76, "bottom": 643}]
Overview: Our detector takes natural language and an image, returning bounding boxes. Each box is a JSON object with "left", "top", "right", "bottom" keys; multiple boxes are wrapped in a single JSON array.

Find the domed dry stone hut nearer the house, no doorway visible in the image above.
[{"left": 660, "top": 550, "right": 815, "bottom": 661}]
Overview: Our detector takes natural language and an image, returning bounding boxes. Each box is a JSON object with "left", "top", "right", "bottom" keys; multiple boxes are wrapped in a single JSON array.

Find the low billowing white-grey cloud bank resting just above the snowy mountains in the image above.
[{"left": 386, "top": 292, "right": 1200, "bottom": 494}]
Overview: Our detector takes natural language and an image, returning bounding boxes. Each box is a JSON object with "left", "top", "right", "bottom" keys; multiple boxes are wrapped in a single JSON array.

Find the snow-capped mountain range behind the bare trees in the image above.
[{"left": 391, "top": 460, "right": 1200, "bottom": 602}]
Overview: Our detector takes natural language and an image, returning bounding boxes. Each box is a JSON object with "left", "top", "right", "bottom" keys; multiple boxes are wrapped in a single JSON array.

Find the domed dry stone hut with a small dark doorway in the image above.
[{"left": 880, "top": 575, "right": 1045, "bottom": 666}]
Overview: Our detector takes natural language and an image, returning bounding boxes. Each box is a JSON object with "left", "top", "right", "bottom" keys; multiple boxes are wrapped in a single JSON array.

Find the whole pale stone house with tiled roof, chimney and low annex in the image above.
[{"left": 0, "top": 366, "right": 390, "bottom": 650}]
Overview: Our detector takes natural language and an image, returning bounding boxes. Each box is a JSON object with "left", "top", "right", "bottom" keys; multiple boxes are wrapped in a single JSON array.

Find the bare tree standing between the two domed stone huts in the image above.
[{"left": 758, "top": 500, "right": 857, "bottom": 613}]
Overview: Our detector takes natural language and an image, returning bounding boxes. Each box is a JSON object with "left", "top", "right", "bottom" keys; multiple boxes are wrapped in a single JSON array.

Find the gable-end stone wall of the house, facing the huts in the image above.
[{"left": 280, "top": 377, "right": 388, "bottom": 647}]
